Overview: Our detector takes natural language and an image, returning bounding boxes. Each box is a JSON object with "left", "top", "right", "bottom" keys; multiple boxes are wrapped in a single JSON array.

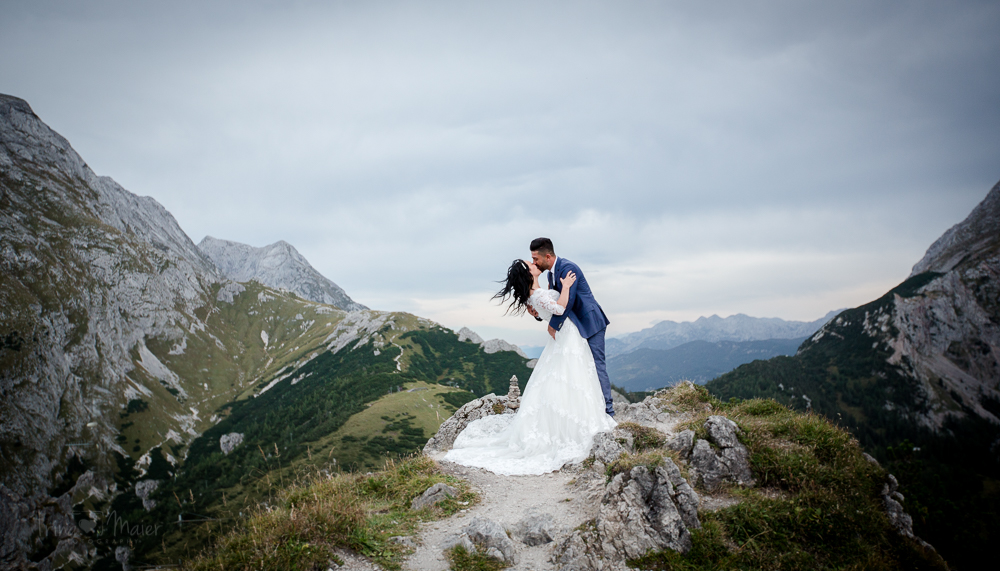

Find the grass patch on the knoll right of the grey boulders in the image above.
[{"left": 623, "top": 399, "right": 947, "bottom": 570}]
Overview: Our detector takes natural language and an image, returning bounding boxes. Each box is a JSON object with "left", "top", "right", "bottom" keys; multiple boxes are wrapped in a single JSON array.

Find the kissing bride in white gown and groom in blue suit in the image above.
[{"left": 443, "top": 238, "right": 617, "bottom": 475}]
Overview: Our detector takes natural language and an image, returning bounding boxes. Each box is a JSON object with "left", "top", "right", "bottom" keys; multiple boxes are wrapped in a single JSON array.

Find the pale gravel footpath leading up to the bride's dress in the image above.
[{"left": 403, "top": 459, "right": 603, "bottom": 571}]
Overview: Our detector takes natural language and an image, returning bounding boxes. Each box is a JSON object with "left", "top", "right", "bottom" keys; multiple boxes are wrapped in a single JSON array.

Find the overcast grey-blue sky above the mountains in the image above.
[{"left": 0, "top": 0, "right": 1000, "bottom": 345}]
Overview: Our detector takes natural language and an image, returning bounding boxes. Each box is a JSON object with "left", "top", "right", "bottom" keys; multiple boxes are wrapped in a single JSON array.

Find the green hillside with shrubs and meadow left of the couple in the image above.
[{"left": 85, "top": 312, "right": 531, "bottom": 568}]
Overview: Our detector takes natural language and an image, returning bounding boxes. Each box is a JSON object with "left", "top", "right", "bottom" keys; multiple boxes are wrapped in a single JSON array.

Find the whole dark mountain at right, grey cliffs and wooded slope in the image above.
[{"left": 707, "top": 180, "right": 1000, "bottom": 568}]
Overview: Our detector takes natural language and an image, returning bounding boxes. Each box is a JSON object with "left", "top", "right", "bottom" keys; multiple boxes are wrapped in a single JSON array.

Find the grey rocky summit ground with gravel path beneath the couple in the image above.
[{"left": 398, "top": 384, "right": 944, "bottom": 571}]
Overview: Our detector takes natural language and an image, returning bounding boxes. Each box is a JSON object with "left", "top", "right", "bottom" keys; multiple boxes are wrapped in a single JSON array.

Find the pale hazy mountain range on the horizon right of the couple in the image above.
[{"left": 607, "top": 311, "right": 839, "bottom": 358}]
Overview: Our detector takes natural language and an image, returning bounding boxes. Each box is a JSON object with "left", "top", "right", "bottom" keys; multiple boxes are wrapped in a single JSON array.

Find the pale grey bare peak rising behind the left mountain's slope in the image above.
[{"left": 198, "top": 236, "right": 368, "bottom": 311}]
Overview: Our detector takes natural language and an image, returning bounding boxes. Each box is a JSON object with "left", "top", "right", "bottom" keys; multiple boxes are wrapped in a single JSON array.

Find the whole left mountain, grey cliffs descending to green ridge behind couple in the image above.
[{"left": 0, "top": 95, "right": 530, "bottom": 569}]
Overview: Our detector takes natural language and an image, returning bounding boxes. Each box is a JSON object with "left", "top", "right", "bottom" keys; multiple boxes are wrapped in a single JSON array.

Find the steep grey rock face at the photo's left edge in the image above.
[{"left": 0, "top": 95, "right": 229, "bottom": 558}]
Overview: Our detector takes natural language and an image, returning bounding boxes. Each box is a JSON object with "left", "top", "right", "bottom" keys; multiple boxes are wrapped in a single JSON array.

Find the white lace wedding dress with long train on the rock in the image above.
[{"left": 444, "top": 289, "right": 617, "bottom": 475}]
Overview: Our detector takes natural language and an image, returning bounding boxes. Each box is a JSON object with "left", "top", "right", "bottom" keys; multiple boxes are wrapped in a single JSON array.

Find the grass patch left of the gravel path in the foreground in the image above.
[{"left": 188, "top": 456, "right": 476, "bottom": 571}]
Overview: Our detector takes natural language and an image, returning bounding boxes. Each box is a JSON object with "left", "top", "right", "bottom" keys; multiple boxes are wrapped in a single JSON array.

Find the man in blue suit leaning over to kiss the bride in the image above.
[{"left": 530, "top": 238, "right": 615, "bottom": 416}]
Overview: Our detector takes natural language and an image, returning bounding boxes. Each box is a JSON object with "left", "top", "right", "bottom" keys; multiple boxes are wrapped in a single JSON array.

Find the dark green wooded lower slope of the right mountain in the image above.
[{"left": 706, "top": 274, "right": 1000, "bottom": 569}]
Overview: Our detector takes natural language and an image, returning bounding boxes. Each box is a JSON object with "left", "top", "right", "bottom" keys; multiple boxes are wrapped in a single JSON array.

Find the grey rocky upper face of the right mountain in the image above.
[{"left": 801, "top": 184, "right": 1000, "bottom": 430}]
